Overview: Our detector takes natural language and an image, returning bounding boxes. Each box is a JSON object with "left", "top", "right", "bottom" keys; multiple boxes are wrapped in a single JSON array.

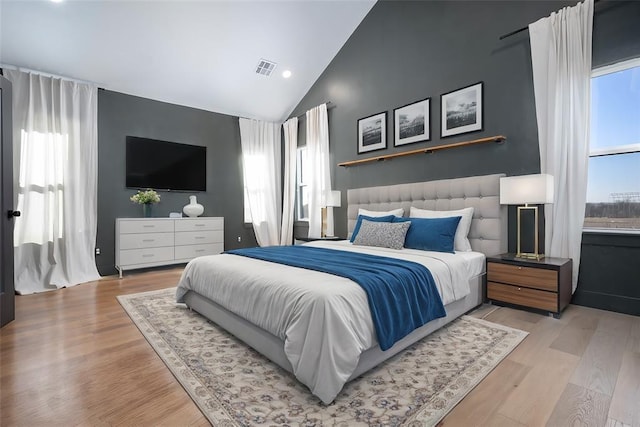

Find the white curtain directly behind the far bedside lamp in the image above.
[{"left": 306, "top": 104, "right": 333, "bottom": 237}]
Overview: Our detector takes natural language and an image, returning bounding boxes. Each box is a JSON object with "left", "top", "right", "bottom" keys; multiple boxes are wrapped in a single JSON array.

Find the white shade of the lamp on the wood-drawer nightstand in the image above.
[{"left": 500, "top": 174, "right": 553, "bottom": 205}]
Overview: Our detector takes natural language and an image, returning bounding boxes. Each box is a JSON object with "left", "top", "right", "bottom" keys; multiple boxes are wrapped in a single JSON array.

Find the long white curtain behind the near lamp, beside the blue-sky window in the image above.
[{"left": 529, "top": 0, "right": 593, "bottom": 292}]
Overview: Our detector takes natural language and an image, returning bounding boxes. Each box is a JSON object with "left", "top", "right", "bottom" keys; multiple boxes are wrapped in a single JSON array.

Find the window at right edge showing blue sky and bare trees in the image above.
[{"left": 584, "top": 58, "right": 640, "bottom": 231}]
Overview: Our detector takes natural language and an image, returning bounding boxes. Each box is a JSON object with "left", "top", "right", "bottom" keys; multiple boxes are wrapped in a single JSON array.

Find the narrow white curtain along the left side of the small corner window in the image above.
[{"left": 280, "top": 117, "right": 298, "bottom": 245}]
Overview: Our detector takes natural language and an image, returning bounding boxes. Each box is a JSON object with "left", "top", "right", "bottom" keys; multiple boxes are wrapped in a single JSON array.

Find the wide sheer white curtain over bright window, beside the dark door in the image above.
[{"left": 4, "top": 69, "right": 100, "bottom": 294}]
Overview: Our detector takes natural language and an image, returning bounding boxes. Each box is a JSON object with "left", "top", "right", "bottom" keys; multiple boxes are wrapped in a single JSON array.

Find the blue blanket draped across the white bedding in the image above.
[{"left": 226, "top": 246, "right": 446, "bottom": 350}]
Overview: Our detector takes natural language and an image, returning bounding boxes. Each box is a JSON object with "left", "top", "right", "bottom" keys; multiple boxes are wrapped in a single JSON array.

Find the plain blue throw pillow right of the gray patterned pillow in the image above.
[{"left": 393, "top": 216, "right": 461, "bottom": 253}]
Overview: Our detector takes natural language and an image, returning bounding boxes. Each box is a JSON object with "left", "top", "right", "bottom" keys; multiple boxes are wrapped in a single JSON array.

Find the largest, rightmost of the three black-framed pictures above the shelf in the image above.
[{"left": 440, "top": 82, "right": 483, "bottom": 138}]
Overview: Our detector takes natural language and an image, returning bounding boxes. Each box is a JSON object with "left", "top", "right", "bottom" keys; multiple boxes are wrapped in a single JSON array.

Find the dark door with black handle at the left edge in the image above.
[{"left": 0, "top": 76, "right": 20, "bottom": 327}]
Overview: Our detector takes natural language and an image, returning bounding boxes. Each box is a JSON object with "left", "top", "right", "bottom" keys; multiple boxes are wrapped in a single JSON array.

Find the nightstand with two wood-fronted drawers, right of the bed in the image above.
[{"left": 487, "top": 254, "right": 573, "bottom": 319}]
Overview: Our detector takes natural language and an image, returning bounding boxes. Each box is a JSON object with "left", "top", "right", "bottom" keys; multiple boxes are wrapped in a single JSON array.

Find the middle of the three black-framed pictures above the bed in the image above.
[{"left": 393, "top": 98, "right": 431, "bottom": 147}]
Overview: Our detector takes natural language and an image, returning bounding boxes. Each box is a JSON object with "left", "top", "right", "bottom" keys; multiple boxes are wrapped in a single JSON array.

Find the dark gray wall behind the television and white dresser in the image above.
[{"left": 96, "top": 90, "right": 256, "bottom": 275}]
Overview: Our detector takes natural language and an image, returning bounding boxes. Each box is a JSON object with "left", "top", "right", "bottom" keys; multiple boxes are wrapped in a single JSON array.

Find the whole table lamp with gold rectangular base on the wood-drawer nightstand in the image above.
[{"left": 500, "top": 174, "right": 553, "bottom": 260}]
